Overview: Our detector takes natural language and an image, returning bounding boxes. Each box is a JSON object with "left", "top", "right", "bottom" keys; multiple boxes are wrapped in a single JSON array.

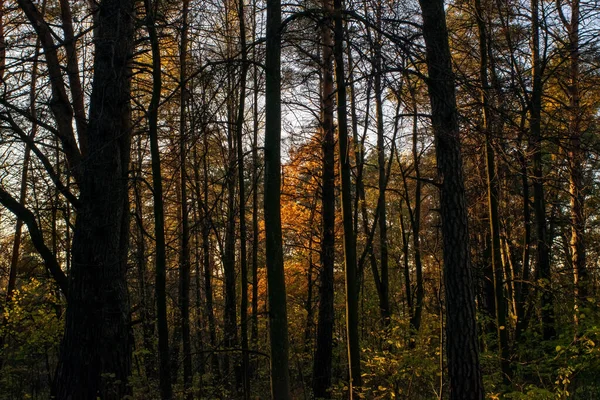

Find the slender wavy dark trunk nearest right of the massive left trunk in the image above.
[{"left": 144, "top": 0, "right": 173, "bottom": 400}]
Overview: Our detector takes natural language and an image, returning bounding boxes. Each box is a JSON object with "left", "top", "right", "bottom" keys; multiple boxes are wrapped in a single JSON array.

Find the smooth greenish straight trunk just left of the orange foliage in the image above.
[{"left": 264, "top": 0, "right": 291, "bottom": 400}]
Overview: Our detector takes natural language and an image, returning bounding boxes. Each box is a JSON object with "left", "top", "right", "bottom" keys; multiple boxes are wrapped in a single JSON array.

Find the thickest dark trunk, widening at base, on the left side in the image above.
[{"left": 53, "top": 0, "right": 134, "bottom": 399}]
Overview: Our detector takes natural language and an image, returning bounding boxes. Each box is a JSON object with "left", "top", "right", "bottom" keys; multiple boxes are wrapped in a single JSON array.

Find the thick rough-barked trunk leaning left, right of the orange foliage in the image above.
[{"left": 419, "top": 0, "right": 485, "bottom": 400}]
